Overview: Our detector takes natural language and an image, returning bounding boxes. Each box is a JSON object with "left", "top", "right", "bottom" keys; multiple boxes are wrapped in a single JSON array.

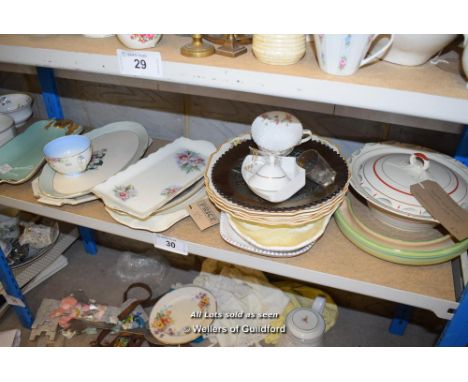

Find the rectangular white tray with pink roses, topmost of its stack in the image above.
[{"left": 93, "top": 137, "right": 216, "bottom": 219}]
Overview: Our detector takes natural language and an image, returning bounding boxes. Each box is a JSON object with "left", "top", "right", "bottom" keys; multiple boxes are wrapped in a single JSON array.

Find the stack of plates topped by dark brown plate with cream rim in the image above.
[{"left": 205, "top": 134, "right": 350, "bottom": 257}]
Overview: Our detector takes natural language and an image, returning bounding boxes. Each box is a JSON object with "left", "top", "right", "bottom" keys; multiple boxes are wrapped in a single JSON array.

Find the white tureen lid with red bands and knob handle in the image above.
[{"left": 351, "top": 144, "right": 468, "bottom": 217}]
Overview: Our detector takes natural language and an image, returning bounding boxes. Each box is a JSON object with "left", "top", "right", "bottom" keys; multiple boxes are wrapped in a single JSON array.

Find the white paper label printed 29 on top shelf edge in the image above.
[{"left": 117, "top": 49, "right": 163, "bottom": 78}]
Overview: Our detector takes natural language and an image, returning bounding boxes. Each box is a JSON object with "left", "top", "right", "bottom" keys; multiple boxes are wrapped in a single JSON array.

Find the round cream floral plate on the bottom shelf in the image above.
[{"left": 149, "top": 286, "right": 216, "bottom": 345}]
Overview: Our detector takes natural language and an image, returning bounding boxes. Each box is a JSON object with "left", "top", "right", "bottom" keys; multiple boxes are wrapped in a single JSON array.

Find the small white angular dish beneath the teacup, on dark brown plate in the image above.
[{"left": 241, "top": 155, "right": 306, "bottom": 203}]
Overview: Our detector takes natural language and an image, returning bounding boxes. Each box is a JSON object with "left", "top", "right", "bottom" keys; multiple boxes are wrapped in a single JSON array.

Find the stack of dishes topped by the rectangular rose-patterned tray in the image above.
[{"left": 93, "top": 137, "right": 216, "bottom": 232}]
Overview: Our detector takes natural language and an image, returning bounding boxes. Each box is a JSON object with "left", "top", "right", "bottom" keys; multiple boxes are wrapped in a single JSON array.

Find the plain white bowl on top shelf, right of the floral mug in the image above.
[{"left": 383, "top": 34, "right": 457, "bottom": 66}]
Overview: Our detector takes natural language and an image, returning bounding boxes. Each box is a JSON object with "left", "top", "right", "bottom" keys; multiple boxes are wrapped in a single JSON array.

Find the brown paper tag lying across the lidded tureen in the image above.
[{"left": 410, "top": 180, "right": 468, "bottom": 241}]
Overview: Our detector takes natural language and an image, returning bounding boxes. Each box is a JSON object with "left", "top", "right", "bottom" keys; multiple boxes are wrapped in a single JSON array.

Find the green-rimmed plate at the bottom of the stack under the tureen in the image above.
[{"left": 335, "top": 198, "right": 468, "bottom": 265}]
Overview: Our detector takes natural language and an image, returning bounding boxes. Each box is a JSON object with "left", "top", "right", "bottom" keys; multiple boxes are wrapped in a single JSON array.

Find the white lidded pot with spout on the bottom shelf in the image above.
[{"left": 278, "top": 297, "right": 326, "bottom": 346}]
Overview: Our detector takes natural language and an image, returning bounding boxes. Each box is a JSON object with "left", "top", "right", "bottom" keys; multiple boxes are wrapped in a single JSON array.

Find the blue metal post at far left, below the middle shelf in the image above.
[{"left": 0, "top": 248, "right": 34, "bottom": 329}]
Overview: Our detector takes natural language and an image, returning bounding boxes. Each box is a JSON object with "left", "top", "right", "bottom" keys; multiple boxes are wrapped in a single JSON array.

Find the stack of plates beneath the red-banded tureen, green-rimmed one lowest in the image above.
[{"left": 335, "top": 193, "right": 468, "bottom": 265}]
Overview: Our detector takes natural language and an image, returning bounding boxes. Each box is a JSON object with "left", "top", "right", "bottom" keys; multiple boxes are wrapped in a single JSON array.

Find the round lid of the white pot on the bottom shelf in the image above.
[{"left": 286, "top": 308, "right": 325, "bottom": 341}]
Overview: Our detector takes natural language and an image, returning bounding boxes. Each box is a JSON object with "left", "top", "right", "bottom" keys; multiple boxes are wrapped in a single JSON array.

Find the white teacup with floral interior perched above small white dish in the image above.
[{"left": 251, "top": 111, "right": 312, "bottom": 155}]
